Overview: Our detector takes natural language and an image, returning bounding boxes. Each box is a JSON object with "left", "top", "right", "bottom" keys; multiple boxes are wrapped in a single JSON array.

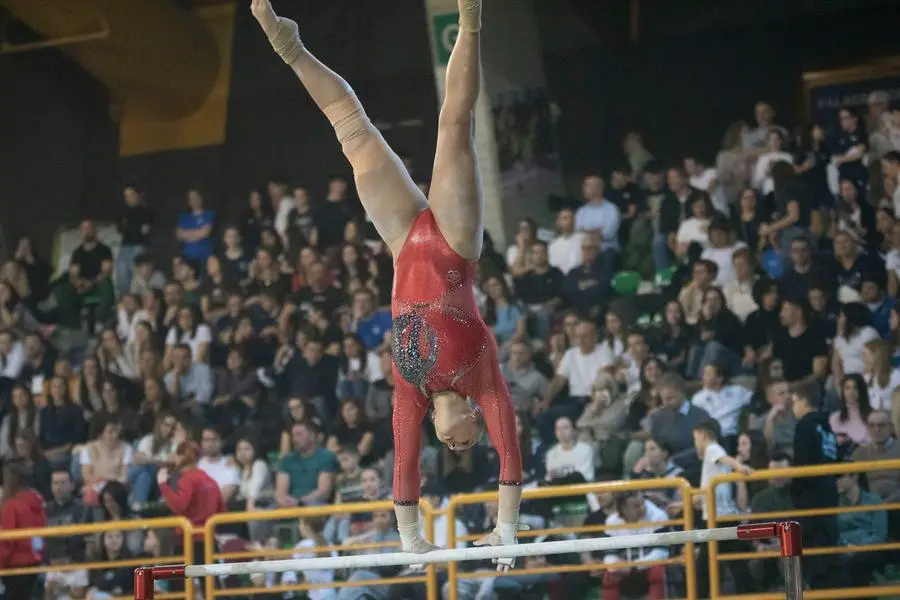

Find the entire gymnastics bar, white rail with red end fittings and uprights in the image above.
[{"left": 134, "top": 521, "right": 803, "bottom": 600}]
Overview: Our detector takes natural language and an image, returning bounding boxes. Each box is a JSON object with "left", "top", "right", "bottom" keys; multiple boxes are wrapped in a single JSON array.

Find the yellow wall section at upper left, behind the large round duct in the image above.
[{"left": 119, "top": 2, "right": 236, "bottom": 156}]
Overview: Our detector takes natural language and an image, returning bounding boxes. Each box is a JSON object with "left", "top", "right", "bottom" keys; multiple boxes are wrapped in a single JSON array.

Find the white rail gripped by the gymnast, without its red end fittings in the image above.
[{"left": 184, "top": 527, "right": 738, "bottom": 577}]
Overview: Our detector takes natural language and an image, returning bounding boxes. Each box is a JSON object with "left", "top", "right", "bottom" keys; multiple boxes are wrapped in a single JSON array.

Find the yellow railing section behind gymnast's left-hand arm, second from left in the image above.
[{"left": 204, "top": 499, "right": 438, "bottom": 600}]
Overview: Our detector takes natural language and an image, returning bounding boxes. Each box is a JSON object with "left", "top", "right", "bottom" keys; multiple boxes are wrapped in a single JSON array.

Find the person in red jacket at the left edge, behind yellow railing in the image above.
[{"left": 0, "top": 460, "right": 47, "bottom": 600}]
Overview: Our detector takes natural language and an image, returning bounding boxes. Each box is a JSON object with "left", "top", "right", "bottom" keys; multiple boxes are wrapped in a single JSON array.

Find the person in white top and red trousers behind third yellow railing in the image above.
[{"left": 603, "top": 492, "right": 670, "bottom": 599}]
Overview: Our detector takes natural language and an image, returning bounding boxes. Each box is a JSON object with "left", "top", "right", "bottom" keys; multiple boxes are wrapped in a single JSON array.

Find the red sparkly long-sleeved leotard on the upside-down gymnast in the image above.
[{"left": 392, "top": 209, "right": 522, "bottom": 504}]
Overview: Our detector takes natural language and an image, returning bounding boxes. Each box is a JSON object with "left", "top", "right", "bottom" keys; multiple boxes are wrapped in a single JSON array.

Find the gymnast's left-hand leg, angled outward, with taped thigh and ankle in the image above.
[{"left": 251, "top": 0, "right": 425, "bottom": 256}]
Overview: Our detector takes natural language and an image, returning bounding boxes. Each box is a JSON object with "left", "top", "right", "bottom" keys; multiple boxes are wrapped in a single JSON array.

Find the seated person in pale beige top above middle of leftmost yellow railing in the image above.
[{"left": 79, "top": 416, "right": 134, "bottom": 504}]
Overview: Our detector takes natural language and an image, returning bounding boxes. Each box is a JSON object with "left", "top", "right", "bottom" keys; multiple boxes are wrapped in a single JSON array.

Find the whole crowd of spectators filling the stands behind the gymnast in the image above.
[{"left": 0, "top": 92, "right": 900, "bottom": 600}]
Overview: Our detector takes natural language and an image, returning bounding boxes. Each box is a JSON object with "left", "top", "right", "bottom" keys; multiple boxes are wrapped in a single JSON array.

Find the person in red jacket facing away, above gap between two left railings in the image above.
[{"left": 156, "top": 440, "right": 227, "bottom": 559}]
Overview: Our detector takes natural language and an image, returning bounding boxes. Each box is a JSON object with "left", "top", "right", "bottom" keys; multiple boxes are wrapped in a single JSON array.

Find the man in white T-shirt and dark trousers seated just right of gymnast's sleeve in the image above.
[{"left": 534, "top": 320, "right": 615, "bottom": 443}]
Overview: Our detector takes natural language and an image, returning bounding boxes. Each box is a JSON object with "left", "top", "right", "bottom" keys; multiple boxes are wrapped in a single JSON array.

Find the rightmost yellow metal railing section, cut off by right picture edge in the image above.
[{"left": 708, "top": 460, "right": 900, "bottom": 600}]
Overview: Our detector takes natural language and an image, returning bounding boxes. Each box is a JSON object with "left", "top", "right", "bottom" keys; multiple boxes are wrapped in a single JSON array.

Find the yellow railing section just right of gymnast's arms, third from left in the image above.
[{"left": 444, "top": 477, "right": 697, "bottom": 600}]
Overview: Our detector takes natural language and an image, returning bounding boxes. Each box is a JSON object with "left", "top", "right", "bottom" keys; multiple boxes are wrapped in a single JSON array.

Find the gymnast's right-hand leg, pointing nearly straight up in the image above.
[{"left": 428, "top": 0, "right": 484, "bottom": 260}]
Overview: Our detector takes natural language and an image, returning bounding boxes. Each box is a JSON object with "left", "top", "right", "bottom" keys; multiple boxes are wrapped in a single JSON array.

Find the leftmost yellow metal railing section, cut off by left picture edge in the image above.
[{"left": 0, "top": 517, "right": 194, "bottom": 600}]
